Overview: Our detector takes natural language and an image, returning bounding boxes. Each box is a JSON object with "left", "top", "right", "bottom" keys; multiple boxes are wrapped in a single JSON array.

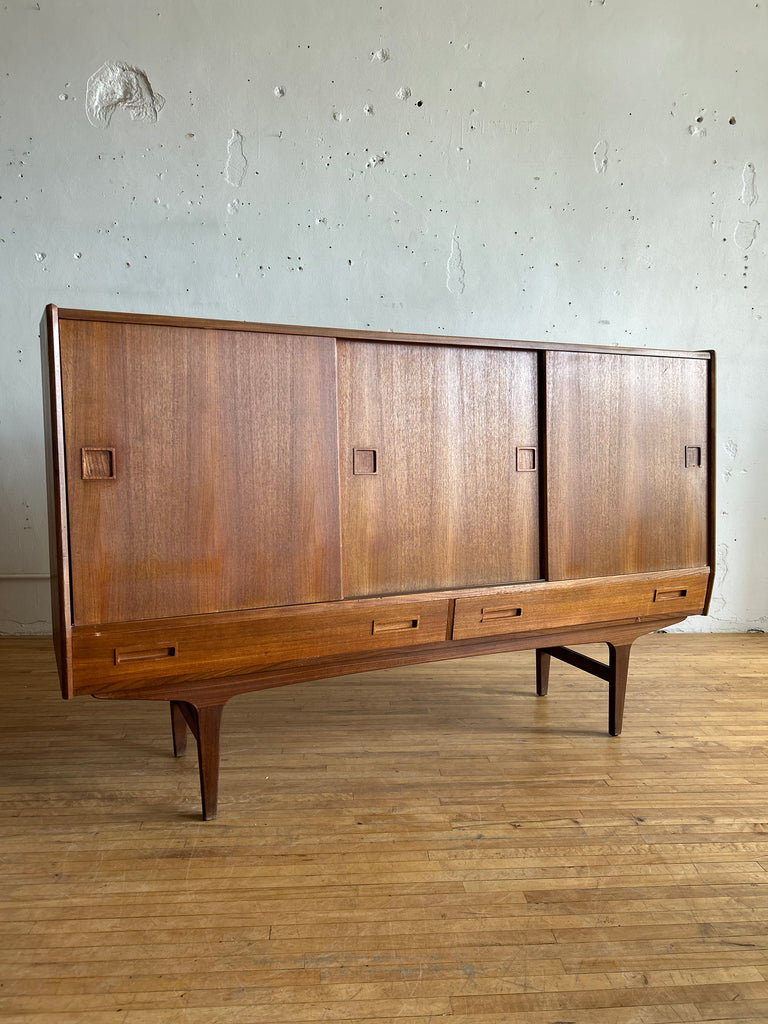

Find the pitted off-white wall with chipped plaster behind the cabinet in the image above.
[{"left": 0, "top": 0, "right": 768, "bottom": 633}]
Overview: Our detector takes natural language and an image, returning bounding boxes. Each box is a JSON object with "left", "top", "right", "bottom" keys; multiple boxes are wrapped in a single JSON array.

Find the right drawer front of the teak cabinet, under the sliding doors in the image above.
[{"left": 453, "top": 569, "right": 710, "bottom": 640}]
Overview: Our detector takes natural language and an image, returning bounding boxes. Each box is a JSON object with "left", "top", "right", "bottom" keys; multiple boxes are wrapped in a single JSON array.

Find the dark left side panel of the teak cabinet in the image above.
[{"left": 40, "top": 305, "right": 75, "bottom": 697}]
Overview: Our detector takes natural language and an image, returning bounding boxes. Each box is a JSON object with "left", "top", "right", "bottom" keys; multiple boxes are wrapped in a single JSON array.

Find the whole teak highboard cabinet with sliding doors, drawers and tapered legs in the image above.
[{"left": 41, "top": 305, "right": 714, "bottom": 818}]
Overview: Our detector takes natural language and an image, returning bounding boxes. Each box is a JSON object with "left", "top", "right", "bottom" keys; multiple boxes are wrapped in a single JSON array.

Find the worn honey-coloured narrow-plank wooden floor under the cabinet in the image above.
[{"left": 0, "top": 635, "right": 768, "bottom": 1024}]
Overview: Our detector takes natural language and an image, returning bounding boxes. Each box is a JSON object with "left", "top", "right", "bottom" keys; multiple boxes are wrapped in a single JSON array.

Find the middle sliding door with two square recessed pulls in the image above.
[{"left": 338, "top": 341, "right": 541, "bottom": 597}]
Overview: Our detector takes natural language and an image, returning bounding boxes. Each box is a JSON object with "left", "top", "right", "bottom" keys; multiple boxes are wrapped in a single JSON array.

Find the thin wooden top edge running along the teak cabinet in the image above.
[{"left": 45, "top": 303, "right": 713, "bottom": 359}]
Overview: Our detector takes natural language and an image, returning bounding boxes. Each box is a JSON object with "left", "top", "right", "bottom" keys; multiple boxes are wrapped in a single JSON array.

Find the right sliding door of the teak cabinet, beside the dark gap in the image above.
[{"left": 546, "top": 351, "right": 709, "bottom": 580}]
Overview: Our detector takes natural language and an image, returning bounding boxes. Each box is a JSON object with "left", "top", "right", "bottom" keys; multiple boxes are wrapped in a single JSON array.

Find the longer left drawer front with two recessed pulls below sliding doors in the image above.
[{"left": 73, "top": 599, "right": 450, "bottom": 693}]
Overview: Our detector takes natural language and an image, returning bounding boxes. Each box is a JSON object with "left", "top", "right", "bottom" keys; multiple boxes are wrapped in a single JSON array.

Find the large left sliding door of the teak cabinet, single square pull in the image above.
[{"left": 60, "top": 321, "right": 340, "bottom": 624}]
